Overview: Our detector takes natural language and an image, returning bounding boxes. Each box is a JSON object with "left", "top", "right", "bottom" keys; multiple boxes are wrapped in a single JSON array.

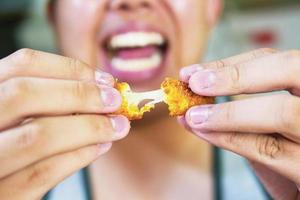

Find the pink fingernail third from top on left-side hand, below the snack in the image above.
[{"left": 110, "top": 115, "right": 130, "bottom": 137}]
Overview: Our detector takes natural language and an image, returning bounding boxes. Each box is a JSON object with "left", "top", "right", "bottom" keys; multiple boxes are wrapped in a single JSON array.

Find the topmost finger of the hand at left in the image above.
[{"left": 0, "top": 49, "right": 114, "bottom": 86}]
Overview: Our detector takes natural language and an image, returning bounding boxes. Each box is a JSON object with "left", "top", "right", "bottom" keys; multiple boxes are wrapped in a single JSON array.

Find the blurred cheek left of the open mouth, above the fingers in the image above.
[{"left": 57, "top": 0, "right": 103, "bottom": 65}]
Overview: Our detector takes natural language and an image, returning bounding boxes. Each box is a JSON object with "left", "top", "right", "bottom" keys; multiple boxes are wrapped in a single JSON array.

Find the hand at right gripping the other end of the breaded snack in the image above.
[{"left": 179, "top": 49, "right": 300, "bottom": 200}]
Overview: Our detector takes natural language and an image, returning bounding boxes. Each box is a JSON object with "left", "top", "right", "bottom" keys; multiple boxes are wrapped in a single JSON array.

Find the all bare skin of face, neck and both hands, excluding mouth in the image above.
[{"left": 0, "top": 0, "right": 300, "bottom": 199}]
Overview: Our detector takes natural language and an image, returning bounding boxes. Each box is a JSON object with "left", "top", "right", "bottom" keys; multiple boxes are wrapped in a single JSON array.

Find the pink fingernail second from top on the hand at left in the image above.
[{"left": 100, "top": 86, "right": 122, "bottom": 112}]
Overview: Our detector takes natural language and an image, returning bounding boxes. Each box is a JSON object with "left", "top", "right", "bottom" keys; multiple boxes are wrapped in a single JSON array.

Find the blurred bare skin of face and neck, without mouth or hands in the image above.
[{"left": 50, "top": 0, "right": 221, "bottom": 199}]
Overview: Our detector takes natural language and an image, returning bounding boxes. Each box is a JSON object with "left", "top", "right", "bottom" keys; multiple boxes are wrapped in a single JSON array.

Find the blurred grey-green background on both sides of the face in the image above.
[{"left": 0, "top": 0, "right": 300, "bottom": 57}]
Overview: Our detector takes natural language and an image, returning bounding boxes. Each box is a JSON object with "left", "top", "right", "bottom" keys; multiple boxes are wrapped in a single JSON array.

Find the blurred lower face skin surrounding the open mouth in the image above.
[{"left": 49, "top": 0, "right": 221, "bottom": 91}]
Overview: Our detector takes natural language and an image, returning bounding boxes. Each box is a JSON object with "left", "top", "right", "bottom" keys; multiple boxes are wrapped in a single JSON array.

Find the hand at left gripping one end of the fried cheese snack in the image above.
[{"left": 0, "top": 49, "right": 130, "bottom": 200}]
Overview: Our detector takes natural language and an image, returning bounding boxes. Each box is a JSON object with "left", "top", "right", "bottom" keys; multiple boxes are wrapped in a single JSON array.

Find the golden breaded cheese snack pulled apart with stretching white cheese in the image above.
[{"left": 115, "top": 78, "right": 214, "bottom": 120}]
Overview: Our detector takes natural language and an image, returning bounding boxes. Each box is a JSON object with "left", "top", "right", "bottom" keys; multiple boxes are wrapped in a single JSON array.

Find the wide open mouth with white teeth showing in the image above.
[{"left": 104, "top": 30, "right": 168, "bottom": 82}]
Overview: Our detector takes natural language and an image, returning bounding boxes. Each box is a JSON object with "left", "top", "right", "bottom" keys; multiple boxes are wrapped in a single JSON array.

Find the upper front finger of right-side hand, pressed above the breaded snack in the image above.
[{"left": 189, "top": 50, "right": 300, "bottom": 96}]
